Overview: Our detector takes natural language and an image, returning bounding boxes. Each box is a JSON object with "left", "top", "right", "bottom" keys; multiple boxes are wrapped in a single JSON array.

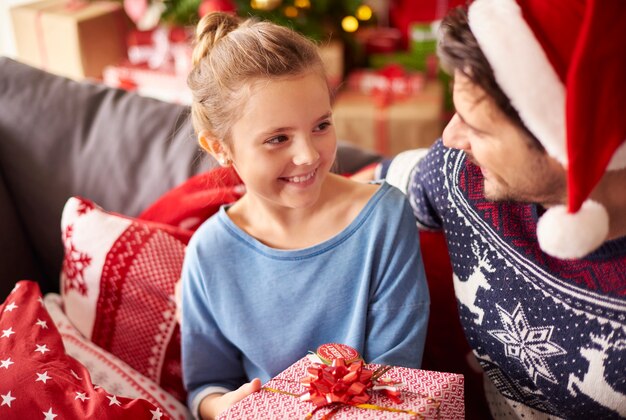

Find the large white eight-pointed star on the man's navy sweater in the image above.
[{"left": 489, "top": 304, "right": 566, "bottom": 383}]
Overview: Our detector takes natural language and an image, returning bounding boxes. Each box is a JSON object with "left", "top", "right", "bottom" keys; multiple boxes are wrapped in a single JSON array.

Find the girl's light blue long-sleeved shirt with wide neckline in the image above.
[{"left": 181, "top": 183, "right": 430, "bottom": 409}]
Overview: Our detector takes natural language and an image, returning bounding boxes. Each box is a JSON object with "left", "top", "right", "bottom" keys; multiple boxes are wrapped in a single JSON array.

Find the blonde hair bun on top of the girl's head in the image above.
[{"left": 192, "top": 12, "right": 241, "bottom": 66}]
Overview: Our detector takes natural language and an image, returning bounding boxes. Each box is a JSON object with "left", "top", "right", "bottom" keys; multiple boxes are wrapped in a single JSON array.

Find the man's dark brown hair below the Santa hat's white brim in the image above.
[{"left": 437, "top": 6, "right": 543, "bottom": 149}]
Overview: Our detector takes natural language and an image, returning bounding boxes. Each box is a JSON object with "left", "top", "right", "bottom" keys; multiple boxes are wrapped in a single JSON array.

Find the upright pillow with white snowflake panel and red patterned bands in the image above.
[{"left": 61, "top": 197, "right": 192, "bottom": 401}]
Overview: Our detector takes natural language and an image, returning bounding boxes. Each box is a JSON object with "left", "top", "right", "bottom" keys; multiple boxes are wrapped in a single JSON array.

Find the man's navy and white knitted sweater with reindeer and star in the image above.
[{"left": 387, "top": 140, "right": 626, "bottom": 419}]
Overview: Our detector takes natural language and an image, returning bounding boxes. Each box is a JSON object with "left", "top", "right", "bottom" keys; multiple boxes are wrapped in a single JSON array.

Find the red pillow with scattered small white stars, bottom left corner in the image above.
[{"left": 0, "top": 281, "right": 169, "bottom": 420}]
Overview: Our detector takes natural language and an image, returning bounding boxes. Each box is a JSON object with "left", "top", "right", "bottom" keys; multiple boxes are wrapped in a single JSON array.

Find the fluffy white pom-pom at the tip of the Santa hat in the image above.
[{"left": 537, "top": 200, "right": 609, "bottom": 260}]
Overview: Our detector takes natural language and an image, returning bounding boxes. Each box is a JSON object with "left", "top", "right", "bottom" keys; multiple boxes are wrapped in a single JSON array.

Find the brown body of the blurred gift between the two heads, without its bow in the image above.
[{"left": 333, "top": 80, "right": 444, "bottom": 156}]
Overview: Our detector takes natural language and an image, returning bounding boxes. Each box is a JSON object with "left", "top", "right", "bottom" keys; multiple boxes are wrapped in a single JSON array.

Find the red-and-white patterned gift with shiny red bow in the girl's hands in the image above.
[{"left": 219, "top": 344, "right": 465, "bottom": 419}]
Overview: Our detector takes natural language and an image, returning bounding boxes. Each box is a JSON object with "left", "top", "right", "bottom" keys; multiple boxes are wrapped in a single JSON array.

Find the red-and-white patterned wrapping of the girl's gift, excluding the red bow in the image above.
[{"left": 219, "top": 357, "right": 465, "bottom": 420}]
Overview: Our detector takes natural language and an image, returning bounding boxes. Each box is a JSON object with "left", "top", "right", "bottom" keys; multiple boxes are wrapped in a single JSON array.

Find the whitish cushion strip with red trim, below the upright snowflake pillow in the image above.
[{"left": 43, "top": 293, "right": 190, "bottom": 420}]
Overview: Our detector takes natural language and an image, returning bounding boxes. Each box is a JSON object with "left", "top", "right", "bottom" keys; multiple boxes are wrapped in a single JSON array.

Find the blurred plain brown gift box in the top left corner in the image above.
[{"left": 11, "top": 0, "right": 127, "bottom": 80}]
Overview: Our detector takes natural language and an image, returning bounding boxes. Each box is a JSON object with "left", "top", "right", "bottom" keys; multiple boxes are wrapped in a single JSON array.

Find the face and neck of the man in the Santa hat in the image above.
[{"left": 443, "top": 70, "right": 567, "bottom": 206}]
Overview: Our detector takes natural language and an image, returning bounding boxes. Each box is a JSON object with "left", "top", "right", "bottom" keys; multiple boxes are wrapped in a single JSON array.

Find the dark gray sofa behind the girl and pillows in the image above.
[{"left": 0, "top": 57, "right": 379, "bottom": 302}]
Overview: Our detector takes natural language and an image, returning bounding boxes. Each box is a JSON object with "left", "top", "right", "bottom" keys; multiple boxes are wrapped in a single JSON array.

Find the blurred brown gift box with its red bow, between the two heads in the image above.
[{"left": 333, "top": 65, "right": 444, "bottom": 156}]
